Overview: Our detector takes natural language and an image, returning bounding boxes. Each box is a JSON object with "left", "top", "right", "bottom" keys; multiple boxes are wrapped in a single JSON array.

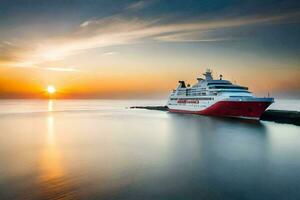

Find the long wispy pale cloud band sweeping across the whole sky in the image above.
[{"left": 0, "top": 12, "right": 300, "bottom": 71}]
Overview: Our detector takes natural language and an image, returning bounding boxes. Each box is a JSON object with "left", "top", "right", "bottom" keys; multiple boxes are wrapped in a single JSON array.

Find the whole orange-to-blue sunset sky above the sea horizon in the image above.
[{"left": 0, "top": 0, "right": 300, "bottom": 98}]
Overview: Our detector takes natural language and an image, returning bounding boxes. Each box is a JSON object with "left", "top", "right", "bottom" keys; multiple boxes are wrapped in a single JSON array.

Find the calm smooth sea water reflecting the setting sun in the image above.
[{"left": 0, "top": 100, "right": 300, "bottom": 200}]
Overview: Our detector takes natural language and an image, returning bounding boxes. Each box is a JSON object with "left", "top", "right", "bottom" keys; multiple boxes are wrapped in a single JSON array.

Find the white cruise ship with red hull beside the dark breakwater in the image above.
[{"left": 167, "top": 69, "right": 274, "bottom": 119}]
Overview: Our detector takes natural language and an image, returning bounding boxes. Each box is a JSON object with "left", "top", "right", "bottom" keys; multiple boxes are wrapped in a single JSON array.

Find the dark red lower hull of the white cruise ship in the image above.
[{"left": 169, "top": 101, "right": 272, "bottom": 119}]
